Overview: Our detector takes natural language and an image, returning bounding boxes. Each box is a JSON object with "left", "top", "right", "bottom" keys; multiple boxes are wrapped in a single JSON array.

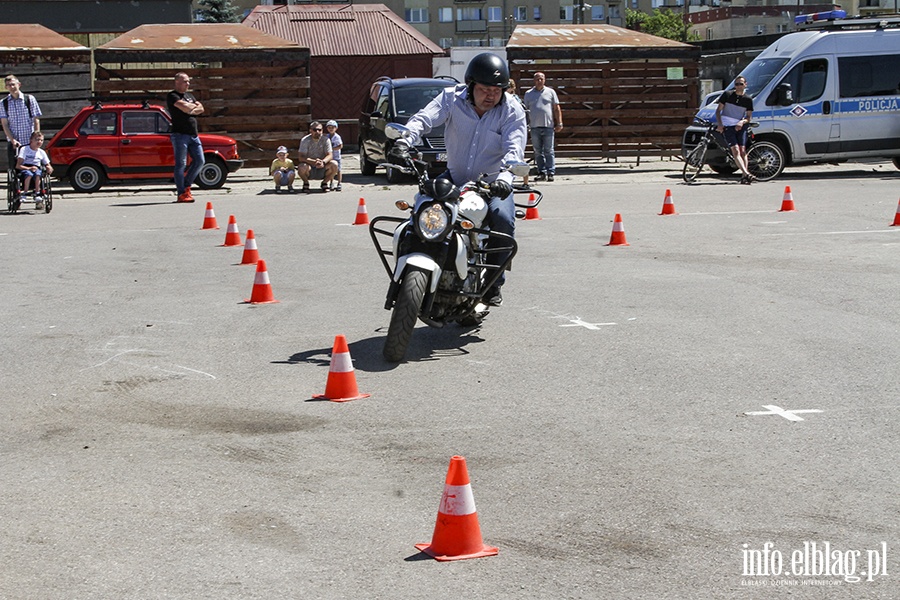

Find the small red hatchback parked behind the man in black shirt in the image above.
[{"left": 44, "top": 103, "right": 244, "bottom": 193}]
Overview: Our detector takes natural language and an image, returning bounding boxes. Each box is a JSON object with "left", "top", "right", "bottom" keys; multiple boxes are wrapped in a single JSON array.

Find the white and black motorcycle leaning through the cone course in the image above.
[{"left": 369, "top": 123, "right": 543, "bottom": 362}]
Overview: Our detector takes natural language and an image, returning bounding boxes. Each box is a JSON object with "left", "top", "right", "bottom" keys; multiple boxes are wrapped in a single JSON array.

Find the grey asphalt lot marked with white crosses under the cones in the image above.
[{"left": 0, "top": 159, "right": 900, "bottom": 600}]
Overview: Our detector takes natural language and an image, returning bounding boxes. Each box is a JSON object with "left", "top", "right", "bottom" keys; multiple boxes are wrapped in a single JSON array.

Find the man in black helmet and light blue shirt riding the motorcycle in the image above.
[{"left": 391, "top": 52, "right": 527, "bottom": 306}]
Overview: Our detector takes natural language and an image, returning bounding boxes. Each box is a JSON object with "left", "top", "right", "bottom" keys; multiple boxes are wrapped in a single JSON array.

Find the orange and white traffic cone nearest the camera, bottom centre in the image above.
[{"left": 416, "top": 456, "right": 500, "bottom": 561}]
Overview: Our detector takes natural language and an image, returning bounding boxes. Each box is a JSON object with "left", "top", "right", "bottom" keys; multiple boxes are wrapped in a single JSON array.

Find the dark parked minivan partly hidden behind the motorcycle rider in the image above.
[{"left": 359, "top": 77, "right": 458, "bottom": 183}]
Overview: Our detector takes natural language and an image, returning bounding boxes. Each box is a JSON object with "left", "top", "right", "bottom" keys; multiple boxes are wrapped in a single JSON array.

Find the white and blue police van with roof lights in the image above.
[{"left": 682, "top": 11, "right": 900, "bottom": 179}]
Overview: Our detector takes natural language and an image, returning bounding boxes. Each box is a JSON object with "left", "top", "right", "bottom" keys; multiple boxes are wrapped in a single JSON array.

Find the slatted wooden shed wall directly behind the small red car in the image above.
[{"left": 94, "top": 48, "right": 311, "bottom": 167}]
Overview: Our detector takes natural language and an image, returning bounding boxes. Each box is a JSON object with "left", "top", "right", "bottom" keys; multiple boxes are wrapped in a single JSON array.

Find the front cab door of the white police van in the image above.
[{"left": 754, "top": 56, "right": 840, "bottom": 161}]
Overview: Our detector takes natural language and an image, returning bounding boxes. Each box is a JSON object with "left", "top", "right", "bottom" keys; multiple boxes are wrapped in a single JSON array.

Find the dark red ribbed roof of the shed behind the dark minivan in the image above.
[{"left": 243, "top": 4, "right": 444, "bottom": 57}]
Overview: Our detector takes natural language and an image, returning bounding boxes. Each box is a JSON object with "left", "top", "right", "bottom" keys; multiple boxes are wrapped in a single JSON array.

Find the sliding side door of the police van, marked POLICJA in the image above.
[{"left": 837, "top": 52, "right": 900, "bottom": 158}]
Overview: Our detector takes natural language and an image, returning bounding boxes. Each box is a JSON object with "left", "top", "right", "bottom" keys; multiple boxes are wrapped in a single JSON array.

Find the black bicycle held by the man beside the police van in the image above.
[{"left": 681, "top": 117, "right": 784, "bottom": 183}]
